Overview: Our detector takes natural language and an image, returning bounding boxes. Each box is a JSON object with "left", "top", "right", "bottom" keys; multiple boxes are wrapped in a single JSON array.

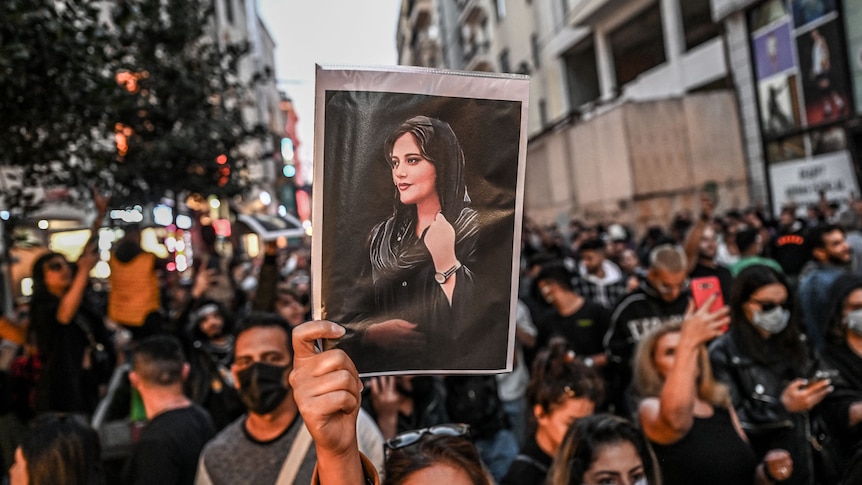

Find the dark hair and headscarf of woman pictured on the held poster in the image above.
[{"left": 383, "top": 116, "right": 470, "bottom": 222}]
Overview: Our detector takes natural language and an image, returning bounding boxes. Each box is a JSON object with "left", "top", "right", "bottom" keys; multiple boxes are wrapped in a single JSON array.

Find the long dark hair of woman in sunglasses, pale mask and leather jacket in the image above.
[{"left": 730, "top": 264, "right": 806, "bottom": 363}]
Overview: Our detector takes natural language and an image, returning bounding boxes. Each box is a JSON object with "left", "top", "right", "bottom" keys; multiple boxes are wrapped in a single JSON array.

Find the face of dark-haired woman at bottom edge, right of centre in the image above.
[{"left": 583, "top": 441, "right": 647, "bottom": 485}]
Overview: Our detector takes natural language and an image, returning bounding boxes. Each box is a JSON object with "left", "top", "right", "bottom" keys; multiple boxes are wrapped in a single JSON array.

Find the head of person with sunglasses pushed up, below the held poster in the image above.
[{"left": 383, "top": 423, "right": 494, "bottom": 485}]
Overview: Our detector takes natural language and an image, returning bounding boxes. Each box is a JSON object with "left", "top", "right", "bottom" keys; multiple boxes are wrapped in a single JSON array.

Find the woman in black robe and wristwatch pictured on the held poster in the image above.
[{"left": 344, "top": 116, "right": 478, "bottom": 371}]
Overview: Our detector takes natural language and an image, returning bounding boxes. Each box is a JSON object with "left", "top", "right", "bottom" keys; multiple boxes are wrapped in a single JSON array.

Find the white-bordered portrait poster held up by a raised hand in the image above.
[{"left": 312, "top": 66, "right": 529, "bottom": 375}]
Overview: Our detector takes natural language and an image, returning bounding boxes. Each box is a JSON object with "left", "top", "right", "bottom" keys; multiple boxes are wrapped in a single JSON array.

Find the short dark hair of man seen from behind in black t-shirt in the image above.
[{"left": 132, "top": 335, "right": 186, "bottom": 386}]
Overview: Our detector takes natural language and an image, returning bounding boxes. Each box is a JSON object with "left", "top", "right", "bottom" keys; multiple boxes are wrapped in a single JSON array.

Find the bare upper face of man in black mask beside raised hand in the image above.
[{"left": 231, "top": 327, "right": 293, "bottom": 387}]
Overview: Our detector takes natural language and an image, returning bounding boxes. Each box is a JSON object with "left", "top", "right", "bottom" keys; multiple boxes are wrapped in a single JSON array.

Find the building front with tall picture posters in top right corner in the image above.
[{"left": 712, "top": 0, "right": 862, "bottom": 212}]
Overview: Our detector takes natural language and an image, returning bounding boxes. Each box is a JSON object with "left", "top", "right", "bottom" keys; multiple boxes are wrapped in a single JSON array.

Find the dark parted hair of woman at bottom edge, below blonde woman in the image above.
[{"left": 548, "top": 414, "right": 661, "bottom": 485}]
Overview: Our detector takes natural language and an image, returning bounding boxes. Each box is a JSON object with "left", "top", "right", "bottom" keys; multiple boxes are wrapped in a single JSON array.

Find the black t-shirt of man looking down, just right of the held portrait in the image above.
[{"left": 536, "top": 301, "right": 610, "bottom": 357}]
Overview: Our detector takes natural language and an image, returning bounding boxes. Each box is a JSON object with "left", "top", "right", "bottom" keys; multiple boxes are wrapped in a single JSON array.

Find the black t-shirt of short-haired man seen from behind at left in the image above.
[{"left": 123, "top": 404, "right": 215, "bottom": 485}]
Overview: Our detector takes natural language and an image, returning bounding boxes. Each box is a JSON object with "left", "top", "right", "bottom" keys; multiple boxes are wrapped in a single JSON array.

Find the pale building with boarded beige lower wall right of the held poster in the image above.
[{"left": 398, "top": 0, "right": 749, "bottom": 233}]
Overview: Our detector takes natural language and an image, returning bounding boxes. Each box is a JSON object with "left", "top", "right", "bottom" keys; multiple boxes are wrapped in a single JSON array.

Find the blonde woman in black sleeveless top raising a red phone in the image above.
[{"left": 635, "top": 314, "right": 793, "bottom": 485}]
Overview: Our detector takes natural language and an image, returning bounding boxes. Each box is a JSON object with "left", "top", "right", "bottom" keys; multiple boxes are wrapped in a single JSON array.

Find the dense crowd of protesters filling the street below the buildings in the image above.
[{"left": 0, "top": 191, "right": 862, "bottom": 485}]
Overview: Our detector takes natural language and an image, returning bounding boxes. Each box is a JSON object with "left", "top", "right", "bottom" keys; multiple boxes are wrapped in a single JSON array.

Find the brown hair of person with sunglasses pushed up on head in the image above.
[{"left": 383, "top": 435, "right": 491, "bottom": 485}]
